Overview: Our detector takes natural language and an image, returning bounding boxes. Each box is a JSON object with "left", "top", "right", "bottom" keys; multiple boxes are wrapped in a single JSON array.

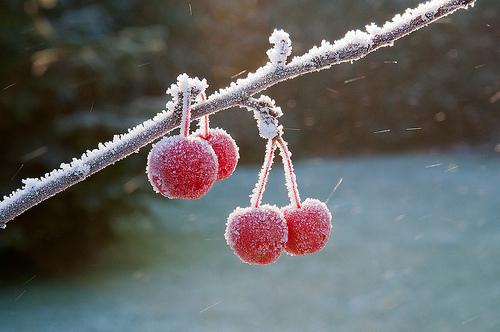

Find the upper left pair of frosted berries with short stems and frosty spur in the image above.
[{"left": 146, "top": 75, "right": 239, "bottom": 199}]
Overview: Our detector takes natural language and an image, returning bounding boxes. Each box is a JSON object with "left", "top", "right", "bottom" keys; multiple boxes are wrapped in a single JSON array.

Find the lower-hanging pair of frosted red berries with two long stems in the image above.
[{"left": 225, "top": 137, "right": 332, "bottom": 265}]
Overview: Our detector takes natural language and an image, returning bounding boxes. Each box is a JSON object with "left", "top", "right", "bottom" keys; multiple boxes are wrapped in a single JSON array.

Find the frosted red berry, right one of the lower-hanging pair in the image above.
[{"left": 281, "top": 198, "right": 332, "bottom": 255}]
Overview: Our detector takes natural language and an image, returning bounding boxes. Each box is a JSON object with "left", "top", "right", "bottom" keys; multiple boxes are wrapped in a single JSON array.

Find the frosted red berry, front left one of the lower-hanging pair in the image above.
[{"left": 224, "top": 204, "right": 288, "bottom": 265}]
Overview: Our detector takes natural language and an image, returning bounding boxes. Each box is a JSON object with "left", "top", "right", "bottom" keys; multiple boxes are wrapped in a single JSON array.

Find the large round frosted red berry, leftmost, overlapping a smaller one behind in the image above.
[{"left": 146, "top": 135, "right": 219, "bottom": 199}]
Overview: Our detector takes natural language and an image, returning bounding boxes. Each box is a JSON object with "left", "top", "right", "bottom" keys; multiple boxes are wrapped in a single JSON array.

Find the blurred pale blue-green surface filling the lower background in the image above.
[{"left": 0, "top": 154, "right": 500, "bottom": 331}]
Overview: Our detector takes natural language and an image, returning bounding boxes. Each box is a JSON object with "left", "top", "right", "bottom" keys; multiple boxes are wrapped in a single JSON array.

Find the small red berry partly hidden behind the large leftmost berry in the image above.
[{"left": 193, "top": 128, "right": 240, "bottom": 181}]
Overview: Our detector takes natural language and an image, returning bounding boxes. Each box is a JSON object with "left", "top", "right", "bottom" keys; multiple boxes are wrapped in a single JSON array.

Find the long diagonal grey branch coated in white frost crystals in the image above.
[{"left": 0, "top": 0, "right": 475, "bottom": 228}]
